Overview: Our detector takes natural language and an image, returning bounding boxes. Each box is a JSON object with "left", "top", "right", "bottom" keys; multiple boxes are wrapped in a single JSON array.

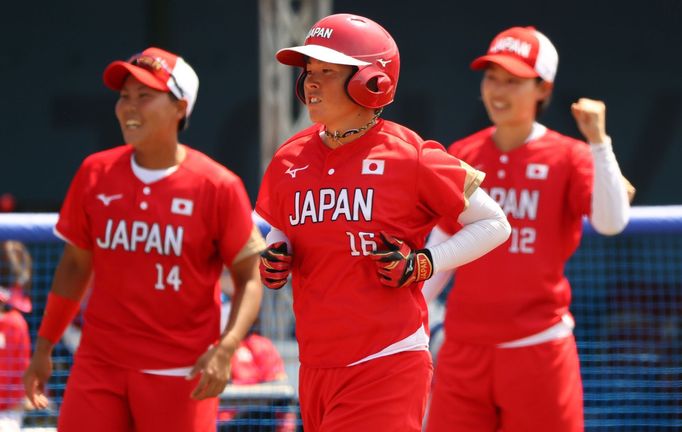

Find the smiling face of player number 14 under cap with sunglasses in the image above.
[{"left": 116, "top": 75, "right": 186, "bottom": 149}]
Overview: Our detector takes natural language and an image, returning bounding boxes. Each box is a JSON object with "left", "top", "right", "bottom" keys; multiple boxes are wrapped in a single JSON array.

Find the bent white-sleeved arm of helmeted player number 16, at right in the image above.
[{"left": 429, "top": 189, "right": 511, "bottom": 273}]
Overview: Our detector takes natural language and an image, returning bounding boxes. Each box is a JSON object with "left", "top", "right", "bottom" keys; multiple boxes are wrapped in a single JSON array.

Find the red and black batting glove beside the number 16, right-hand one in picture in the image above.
[{"left": 370, "top": 231, "right": 433, "bottom": 288}]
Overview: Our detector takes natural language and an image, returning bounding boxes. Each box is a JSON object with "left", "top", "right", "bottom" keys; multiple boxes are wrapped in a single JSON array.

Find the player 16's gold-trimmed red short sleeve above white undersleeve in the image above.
[{"left": 417, "top": 141, "right": 485, "bottom": 220}]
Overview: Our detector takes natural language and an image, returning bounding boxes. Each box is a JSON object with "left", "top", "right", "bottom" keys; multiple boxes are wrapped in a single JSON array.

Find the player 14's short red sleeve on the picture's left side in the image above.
[{"left": 55, "top": 159, "right": 93, "bottom": 250}]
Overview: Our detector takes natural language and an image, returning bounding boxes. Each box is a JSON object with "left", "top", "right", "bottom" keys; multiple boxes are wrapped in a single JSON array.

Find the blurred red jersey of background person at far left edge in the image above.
[{"left": 0, "top": 309, "right": 31, "bottom": 410}]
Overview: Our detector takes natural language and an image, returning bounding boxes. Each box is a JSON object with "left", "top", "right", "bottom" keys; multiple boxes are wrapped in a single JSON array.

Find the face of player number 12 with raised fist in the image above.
[{"left": 481, "top": 63, "right": 552, "bottom": 127}]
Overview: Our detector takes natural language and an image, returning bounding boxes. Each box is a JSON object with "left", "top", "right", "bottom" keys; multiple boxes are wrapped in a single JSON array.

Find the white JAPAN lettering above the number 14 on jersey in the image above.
[{"left": 96, "top": 219, "right": 185, "bottom": 256}]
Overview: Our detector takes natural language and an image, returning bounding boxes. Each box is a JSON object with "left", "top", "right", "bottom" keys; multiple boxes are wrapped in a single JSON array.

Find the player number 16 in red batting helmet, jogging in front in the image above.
[{"left": 256, "top": 14, "right": 508, "bottom": 432}]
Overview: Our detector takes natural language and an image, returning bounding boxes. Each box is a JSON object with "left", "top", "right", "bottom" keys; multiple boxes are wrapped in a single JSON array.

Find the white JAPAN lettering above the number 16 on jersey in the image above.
[{"left": 289, "top": 188, "right": 374, "bottom": 226}]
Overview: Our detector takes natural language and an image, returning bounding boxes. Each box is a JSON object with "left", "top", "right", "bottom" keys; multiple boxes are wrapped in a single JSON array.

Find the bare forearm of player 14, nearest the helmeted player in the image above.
[{"left": 219, "top": 255, "right": 263, "bottom": 353}]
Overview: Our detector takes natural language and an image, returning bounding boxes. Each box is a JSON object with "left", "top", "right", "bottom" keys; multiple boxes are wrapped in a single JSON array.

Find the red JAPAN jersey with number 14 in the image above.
[{"left": 56, "top": 145, "right": 254, "bottom": 369}]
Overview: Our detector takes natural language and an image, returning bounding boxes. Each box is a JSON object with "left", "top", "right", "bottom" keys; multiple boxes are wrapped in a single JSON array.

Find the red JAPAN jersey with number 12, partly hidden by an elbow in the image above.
[{"left": 441, "top": 127, "right": 594, "bottom": 343}]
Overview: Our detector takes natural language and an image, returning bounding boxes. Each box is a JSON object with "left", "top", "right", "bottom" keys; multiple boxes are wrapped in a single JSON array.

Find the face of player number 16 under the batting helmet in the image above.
[{"left": 303, "top": 58, "right": 367, "bottom": 130}]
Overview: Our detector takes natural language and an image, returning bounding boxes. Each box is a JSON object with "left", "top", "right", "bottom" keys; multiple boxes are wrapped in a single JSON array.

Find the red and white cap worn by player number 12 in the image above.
[{"left": 471, "top": 27, "right": 559, "bottom": 82}]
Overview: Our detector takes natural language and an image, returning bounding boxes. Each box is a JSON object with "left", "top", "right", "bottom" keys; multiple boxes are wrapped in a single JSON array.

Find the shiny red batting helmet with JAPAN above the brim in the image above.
[{"left": 277, "top": 14, "right": 400, "bottom": 108}]
